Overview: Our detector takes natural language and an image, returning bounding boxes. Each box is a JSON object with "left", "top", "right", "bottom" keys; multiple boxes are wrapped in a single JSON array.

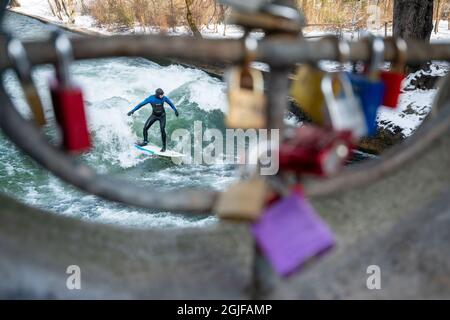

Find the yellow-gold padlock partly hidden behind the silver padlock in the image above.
[{"left": 290, "top": 64, "right": 326, "bottom": 125}]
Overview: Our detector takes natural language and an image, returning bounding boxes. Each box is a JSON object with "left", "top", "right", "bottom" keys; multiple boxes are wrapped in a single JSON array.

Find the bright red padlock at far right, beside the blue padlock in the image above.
[{"left": 381, "top": 38, "right": 408, "bottom": 109}]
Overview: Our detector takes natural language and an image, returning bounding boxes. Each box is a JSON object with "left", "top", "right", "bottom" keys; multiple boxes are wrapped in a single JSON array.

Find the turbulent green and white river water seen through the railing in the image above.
[{"left": 0, "top": 13, "right": 239, "bottom": 228}]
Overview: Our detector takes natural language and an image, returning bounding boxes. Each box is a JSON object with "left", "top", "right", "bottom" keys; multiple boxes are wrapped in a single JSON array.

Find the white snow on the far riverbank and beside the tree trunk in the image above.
[{"left": 8, "top": 0, "right": 450, "bottom": 137}]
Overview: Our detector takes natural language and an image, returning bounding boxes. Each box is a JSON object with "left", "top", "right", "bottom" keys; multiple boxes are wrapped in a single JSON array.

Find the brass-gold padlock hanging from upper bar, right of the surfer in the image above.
[{"left": 225, "top": 67, "right": 267, "bottom": 129}]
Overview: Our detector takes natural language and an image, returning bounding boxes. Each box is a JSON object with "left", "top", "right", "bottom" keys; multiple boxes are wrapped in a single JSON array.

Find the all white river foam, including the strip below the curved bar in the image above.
[{"left": 2, "top": 37, "right": 239, "bottom": 228}]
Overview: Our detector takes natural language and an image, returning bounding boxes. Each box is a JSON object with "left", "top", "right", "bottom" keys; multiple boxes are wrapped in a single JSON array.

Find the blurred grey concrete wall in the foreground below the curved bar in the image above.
[{"left": 0, "top": 114, "right": 450, "bottom": 299}]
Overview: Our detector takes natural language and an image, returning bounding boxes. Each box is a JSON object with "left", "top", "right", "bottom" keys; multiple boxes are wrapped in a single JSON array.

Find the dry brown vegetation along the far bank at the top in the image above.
[{"left": 11, "top": 0, "right": 450, "bottom": 36}]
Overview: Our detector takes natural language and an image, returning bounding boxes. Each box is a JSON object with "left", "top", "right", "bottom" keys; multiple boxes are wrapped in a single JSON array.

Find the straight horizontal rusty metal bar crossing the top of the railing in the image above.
[{"left": 0, "top": 35, "right": 450, "bottom": 69}]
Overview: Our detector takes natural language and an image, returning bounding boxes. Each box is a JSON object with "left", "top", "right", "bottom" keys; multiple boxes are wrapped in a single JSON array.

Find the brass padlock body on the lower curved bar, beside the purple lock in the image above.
[{"left": 214, "top": 176, "right": 269, "bottom": 221}]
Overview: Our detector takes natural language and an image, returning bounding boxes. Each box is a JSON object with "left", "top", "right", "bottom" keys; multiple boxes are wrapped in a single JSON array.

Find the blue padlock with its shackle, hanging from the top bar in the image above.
[{"left": 349, "top": 37, "right": 385, "bottom": 136}]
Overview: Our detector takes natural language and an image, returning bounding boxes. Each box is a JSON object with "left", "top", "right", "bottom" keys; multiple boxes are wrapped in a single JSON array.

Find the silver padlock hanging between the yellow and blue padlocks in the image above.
[{"left": 322, "top": 72, "right": 368, "bottom": 139}]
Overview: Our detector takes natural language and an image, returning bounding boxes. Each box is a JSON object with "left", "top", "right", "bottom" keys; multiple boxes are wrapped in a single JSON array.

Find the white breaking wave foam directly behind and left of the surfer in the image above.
[{"left": 67, "top": 58, "right": 226, "bottom": 168}]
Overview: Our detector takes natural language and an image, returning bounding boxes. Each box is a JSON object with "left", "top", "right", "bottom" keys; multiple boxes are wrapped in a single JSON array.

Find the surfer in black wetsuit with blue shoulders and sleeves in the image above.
[{"left": 127, "top": 88, "right": 178, "bottom": 152}]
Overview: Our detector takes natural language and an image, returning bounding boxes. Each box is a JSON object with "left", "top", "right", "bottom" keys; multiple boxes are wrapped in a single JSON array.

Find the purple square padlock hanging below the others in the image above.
[{"left": 252, "top": 192, "right": 335, "bottom": 276}]
